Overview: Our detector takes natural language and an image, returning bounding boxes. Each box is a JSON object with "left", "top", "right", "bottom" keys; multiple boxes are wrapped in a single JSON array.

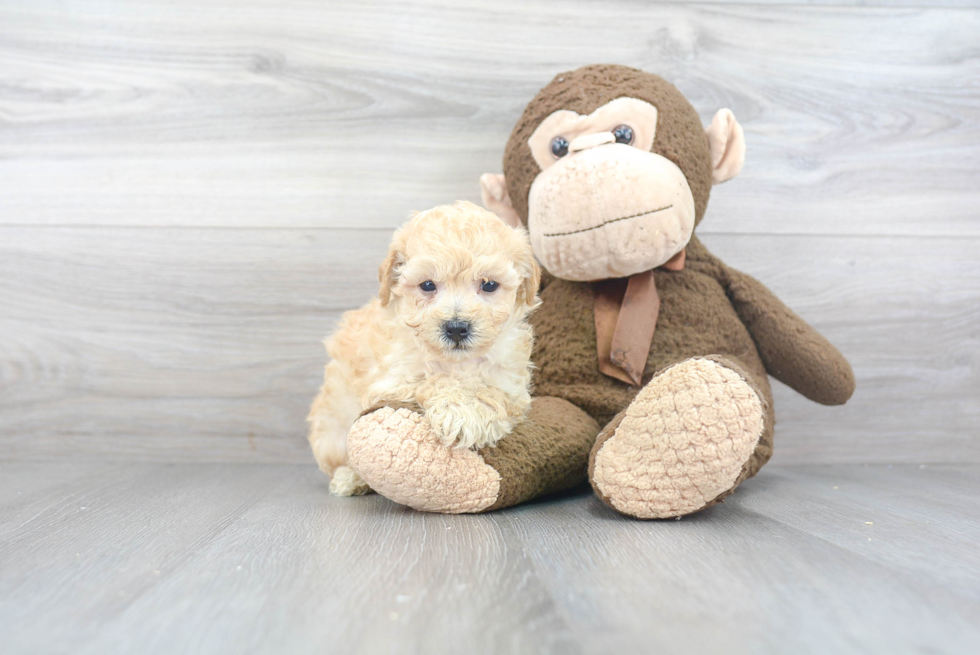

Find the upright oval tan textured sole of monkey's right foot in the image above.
[{"left": 591, "top": 359, "right": 765, "bottom": 519}]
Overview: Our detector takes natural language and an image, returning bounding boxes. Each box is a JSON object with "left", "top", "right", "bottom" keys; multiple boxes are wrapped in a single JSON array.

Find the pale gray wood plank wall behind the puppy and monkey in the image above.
[{"left": 0, "top": 0, "right": 980, "bottom": 463}]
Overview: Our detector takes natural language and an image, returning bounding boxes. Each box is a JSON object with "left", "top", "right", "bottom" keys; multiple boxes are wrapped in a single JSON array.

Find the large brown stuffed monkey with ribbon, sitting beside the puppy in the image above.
[{"left": 348, "top": 65, "right": 854, "bottom": 518}]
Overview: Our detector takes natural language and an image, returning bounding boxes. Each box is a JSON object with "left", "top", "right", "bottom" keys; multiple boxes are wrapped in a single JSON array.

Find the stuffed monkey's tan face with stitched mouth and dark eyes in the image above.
[{"left": 528, "top": 98, "right": 695, "bottom": 282}]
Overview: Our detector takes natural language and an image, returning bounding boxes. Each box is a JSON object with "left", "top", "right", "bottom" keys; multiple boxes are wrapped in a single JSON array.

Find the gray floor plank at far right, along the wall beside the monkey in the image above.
[{"left": 737, "top": 465, "right": 980, "bottom": 597}]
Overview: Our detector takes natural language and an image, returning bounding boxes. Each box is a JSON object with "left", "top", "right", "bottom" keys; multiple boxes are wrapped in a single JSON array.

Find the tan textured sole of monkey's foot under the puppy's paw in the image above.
[{"left": 347, "top": 407, "right": 500, "bottom": 514}]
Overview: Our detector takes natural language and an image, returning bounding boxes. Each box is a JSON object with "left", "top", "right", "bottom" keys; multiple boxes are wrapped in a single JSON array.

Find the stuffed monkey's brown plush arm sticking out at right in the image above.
[{"left": 725, "top": 266, "right": 854, "bottom": 405}]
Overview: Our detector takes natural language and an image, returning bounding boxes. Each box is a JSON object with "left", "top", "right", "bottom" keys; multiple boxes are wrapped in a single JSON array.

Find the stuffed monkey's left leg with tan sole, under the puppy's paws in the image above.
[{"left": 347, "top": 398, "right": 599, "bottom": 514}]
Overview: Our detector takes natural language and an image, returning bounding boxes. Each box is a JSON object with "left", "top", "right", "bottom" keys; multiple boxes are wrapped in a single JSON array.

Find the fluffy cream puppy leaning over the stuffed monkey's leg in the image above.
[{"left": 309, "top": 202, "right": 541, "bottom": 496}]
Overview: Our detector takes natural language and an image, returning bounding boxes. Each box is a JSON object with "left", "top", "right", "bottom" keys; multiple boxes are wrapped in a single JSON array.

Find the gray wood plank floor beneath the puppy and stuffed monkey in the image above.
[{"left": 0, "top": 461, "right": 980, "bottom": 654}]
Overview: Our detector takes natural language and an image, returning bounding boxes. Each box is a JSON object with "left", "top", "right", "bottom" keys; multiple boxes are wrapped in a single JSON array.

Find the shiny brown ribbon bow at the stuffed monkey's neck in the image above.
[{"left": 594, "top": 250, "right": 687, "bottom": 386}]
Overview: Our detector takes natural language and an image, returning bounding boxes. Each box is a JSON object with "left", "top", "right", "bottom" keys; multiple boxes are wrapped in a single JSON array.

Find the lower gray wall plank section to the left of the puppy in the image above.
[{"left": 0, "top": 229, "right": 389, "bottom": 461}]
